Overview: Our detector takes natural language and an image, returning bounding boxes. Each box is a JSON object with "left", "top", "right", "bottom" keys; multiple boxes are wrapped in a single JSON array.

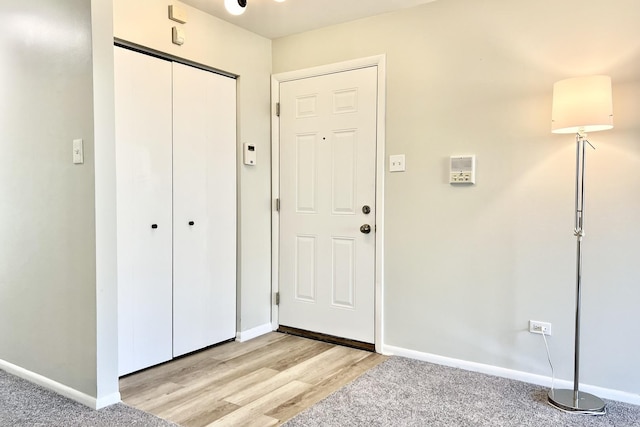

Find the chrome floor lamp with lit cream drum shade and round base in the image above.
[{"left": 549, "top": 76, "right": 613, "bottom": 414}]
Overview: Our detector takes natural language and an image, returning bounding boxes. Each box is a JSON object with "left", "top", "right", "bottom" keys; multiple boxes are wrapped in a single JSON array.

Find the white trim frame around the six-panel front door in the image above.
[{"left": 271, "top": 54, "right": 386, "bottom": 353}]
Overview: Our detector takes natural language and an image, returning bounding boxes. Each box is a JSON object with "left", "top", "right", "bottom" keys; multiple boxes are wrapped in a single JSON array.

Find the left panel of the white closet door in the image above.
[{"left": 114, "top": 48, "right": 172, "bottom": 375}]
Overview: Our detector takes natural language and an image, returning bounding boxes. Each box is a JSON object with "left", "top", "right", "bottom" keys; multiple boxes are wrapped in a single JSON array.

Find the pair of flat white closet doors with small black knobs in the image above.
[{"left": 114, "top": 47, "right": 236, "bottom": 375}]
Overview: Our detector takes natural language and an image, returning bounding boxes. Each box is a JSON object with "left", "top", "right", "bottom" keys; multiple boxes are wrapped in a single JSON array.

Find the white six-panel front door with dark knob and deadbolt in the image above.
[{"left": 279, "top": 67, "right": 377, "bottom": 343}]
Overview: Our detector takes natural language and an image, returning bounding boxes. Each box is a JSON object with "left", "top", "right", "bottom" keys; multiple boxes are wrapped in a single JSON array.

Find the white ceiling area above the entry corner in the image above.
[{"left": 182, "top": 0, "right": 435, "bottom": 39}]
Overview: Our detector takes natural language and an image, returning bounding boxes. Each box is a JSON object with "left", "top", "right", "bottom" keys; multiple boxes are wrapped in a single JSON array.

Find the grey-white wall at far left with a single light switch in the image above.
[{"left": 0, "top": 0, "right": 96, "bottom": 396}]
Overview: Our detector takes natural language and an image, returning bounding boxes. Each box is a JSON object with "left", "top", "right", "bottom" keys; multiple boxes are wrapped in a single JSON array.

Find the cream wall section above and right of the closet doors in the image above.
[{"left": 114, "top": 0, "right": 271, "bottom": 332}]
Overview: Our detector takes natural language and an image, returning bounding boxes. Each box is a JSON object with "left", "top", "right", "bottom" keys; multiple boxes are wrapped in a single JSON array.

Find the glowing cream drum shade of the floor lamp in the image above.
[{"left": 551, "top": 76, "right": 613, "bottom": 133}]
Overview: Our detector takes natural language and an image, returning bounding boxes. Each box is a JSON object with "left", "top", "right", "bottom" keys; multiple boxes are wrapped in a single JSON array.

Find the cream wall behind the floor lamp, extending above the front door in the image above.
[{"left": 273, "top": 0, "right": 640, "bottom": 394}]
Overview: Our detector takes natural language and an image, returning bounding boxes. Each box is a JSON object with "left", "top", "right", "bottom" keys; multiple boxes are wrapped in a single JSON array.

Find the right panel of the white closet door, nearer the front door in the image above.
[{"left": 173, "top": 63, "right": 236, "bottom": 357}]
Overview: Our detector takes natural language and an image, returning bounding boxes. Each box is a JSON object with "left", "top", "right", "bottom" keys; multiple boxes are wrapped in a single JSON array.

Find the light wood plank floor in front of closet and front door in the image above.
[{"left": 120, "top": 332, "right": 386, "bottom": 427}]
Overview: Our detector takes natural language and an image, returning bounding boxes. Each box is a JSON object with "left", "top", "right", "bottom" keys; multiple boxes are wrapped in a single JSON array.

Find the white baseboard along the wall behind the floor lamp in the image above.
[{"left": 382, "top": 345, "right": 640, "bottom": 405}]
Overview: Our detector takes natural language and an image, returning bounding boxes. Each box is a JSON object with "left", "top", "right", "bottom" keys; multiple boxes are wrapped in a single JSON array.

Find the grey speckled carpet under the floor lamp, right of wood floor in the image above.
[{"left": 284, "top": 357, "right": 640, "bottom": 427}]
